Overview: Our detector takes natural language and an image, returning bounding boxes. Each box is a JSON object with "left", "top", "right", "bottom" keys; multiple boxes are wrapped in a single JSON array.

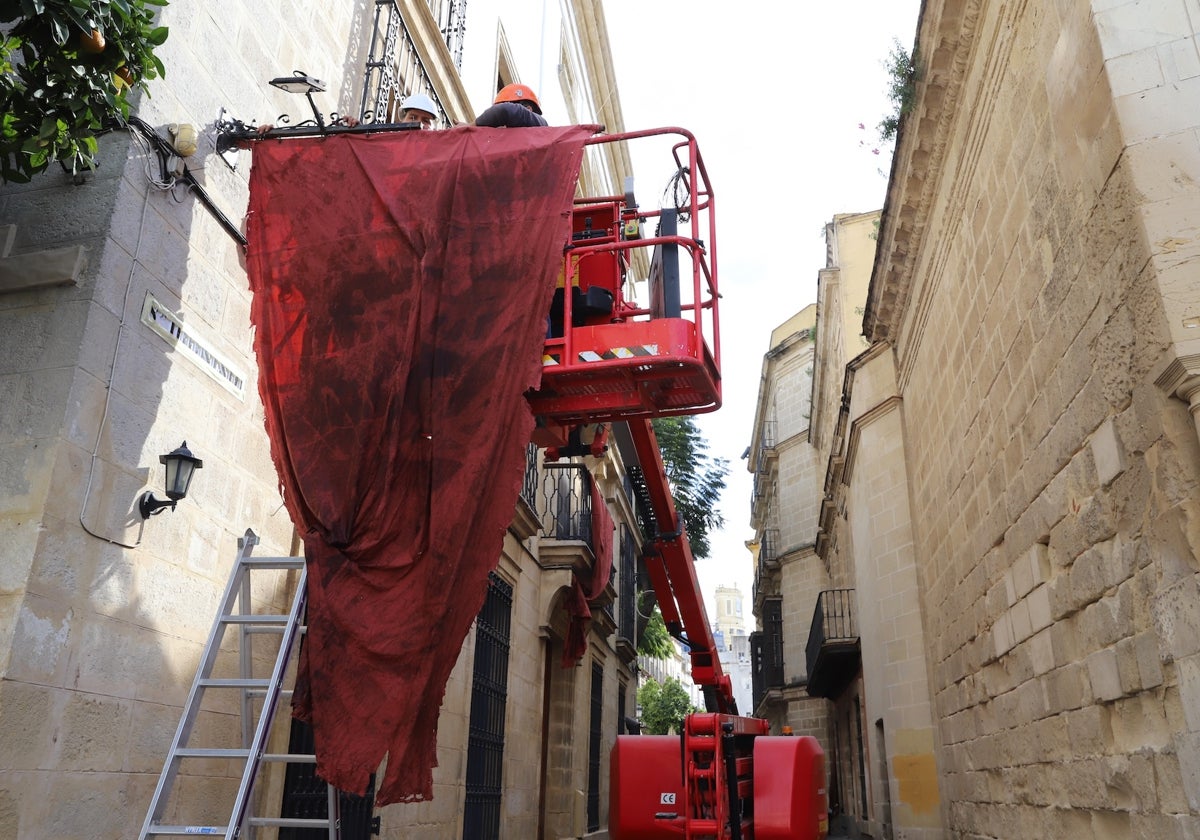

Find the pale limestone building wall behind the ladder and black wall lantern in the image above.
[{"left": 0, "top": 1, "right": 398, "bottom": 840}]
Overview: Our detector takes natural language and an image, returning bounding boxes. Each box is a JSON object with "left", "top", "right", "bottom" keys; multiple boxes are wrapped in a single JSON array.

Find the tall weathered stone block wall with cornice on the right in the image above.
[{"left": 871, "top": 0, "right": 1200, "bottom": 838}]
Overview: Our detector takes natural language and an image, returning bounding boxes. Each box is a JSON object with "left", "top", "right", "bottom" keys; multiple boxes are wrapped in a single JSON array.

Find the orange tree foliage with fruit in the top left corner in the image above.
[{"left": 0, "top": 0, "right": 167, "bottom": 182}]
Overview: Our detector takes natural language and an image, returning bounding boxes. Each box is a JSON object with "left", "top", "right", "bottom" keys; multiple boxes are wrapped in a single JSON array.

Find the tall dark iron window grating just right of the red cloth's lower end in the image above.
[{"left": 462, "top": 572, "right": 512, "bottom": 840}]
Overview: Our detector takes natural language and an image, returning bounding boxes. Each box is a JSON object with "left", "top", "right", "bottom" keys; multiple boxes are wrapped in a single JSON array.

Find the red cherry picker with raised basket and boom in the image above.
[{"left": 528, "top": 128, "right": 827, "bottom": 840}]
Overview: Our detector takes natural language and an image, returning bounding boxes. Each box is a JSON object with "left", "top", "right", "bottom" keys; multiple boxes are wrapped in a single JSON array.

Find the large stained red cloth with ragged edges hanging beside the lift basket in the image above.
[{"left": 247, "top": 126, "right": 595, "bottom": 805}]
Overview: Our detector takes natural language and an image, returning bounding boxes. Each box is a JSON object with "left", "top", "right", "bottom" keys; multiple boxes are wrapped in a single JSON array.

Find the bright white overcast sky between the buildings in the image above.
[{"left": 604, "top": 0, "right": 920, "bottom": 629}]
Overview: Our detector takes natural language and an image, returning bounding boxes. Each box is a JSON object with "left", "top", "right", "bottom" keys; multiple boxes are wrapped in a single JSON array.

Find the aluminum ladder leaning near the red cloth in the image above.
[{"left": 138, "top": 529, "right": 340, "bottom": 840}]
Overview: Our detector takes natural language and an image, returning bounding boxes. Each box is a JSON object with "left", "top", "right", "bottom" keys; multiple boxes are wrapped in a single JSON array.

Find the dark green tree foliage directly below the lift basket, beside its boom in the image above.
[{"left": 654, "top": 418, "right": 730, "bottom": 559}]
